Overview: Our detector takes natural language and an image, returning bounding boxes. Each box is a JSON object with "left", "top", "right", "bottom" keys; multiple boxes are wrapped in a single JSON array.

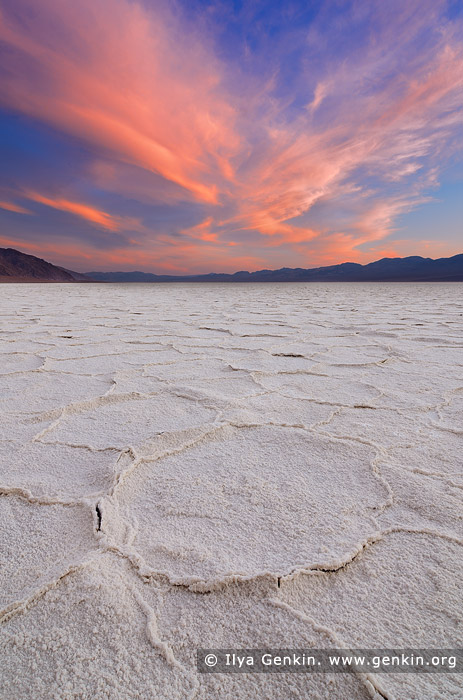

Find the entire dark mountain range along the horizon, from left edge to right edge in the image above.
[{"left": 0, "top": 243, "right": 463, "bottom": 282}]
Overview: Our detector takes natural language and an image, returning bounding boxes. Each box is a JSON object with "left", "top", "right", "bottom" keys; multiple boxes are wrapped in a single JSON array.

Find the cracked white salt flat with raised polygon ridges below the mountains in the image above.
[{"left": 0, "top": 284, "right": 463, "bottom": 700}]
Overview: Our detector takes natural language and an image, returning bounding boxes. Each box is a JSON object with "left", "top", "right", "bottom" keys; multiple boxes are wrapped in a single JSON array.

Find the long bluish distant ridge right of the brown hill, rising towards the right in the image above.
[{"left": 87, "top": 254, "right": 463, "bottom": 282}]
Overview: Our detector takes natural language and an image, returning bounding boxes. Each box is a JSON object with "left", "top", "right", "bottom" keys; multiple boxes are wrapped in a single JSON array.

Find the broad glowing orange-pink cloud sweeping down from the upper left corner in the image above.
[{"left": 0, "top": 0, "right": 239, "bottom": 203}]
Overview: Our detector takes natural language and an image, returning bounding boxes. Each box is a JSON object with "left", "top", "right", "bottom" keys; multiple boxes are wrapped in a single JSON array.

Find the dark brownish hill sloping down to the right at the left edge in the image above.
[{"left": 0, "top": 248, "right": 92, "bottom": 282}]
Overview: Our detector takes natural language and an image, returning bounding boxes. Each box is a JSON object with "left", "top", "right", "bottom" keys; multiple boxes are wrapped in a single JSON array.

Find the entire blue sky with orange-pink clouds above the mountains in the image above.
[{"left": 0, "top": 0, "right": 463, "bottom": 274}]
